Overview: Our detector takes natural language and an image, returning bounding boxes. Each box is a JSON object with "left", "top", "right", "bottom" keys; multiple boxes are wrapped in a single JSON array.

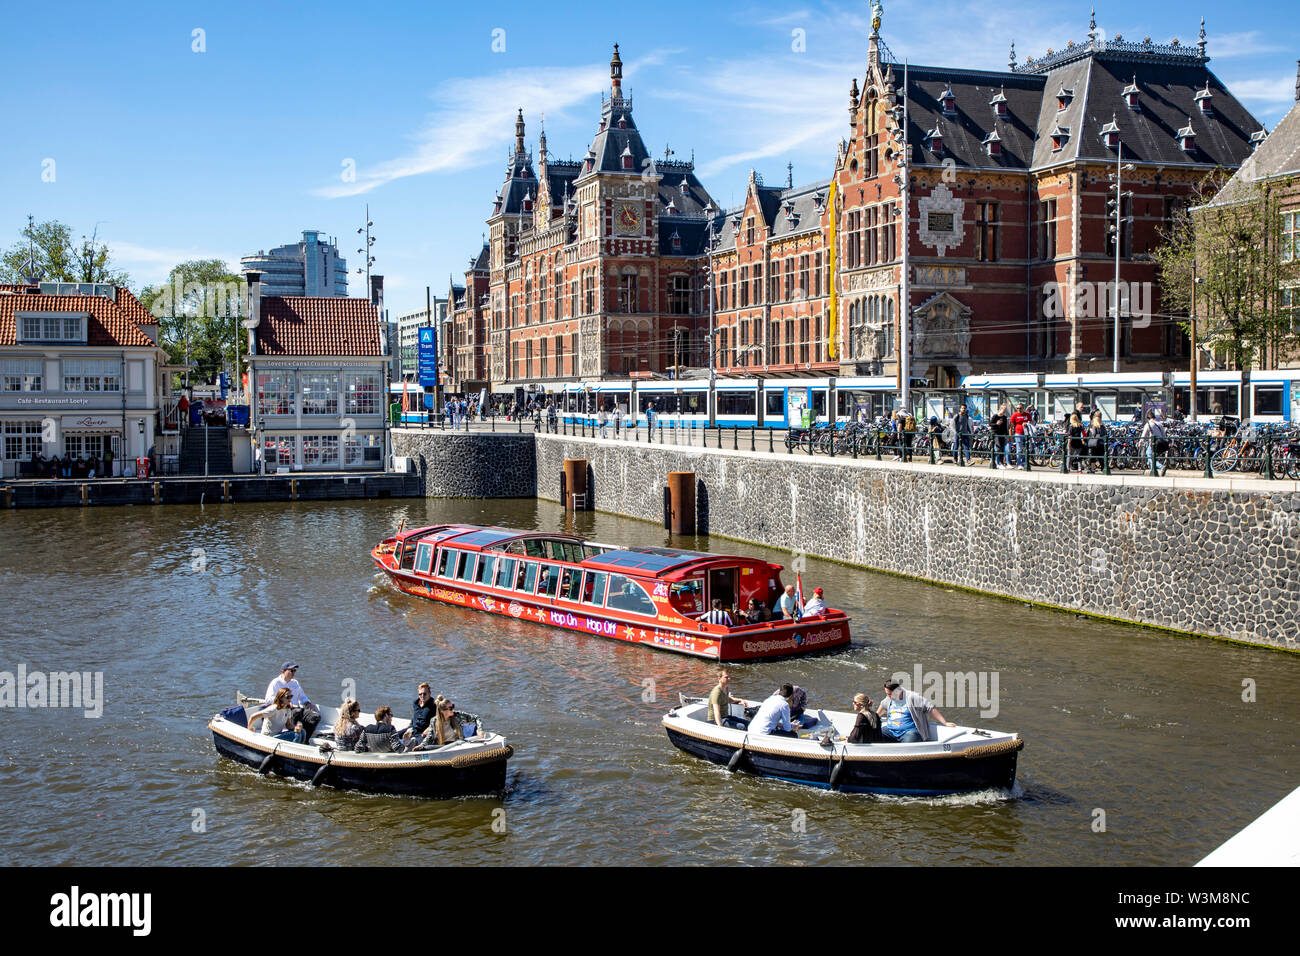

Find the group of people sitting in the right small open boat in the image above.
[{"left": 707, "top": 670, "right": 957, "bottom": 744}]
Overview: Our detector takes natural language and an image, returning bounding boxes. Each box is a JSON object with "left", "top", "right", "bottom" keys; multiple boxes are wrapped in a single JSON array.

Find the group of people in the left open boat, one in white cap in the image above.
[{"left": 248, "top": 661, "right": 478, "bottom": 753}]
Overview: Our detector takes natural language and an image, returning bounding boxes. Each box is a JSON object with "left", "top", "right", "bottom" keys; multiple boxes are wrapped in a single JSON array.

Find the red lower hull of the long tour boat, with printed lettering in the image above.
[{"left": 374, "top": 564, "right": 850, "bottom": 663}]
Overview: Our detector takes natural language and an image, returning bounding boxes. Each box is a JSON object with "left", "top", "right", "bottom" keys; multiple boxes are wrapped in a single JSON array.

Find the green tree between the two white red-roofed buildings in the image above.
[{"left": 140, "top": 259, "right": 248, "bottom": 384}]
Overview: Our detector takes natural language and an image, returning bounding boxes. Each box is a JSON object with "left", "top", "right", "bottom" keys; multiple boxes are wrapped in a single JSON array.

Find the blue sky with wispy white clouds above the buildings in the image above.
[{"left": 0, "top": 0, "right": 1300, "bottom": 313}]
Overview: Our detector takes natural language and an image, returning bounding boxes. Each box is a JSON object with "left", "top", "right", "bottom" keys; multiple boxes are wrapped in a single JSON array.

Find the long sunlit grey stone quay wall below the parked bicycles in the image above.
[{"left": 536, "top": 434, "right": 1300, "bottom": 649}]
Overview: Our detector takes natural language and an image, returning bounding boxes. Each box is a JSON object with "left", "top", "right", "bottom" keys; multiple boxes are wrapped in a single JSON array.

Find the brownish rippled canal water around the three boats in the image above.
[{"left": 0, "top": 499, "right": 1300, "bottom": 865}]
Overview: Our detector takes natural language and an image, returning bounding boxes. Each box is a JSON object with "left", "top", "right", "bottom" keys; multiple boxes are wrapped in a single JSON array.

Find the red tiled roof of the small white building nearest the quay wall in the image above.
[{"left": 256, "top": 295, "right": 384, "bottom": 355}]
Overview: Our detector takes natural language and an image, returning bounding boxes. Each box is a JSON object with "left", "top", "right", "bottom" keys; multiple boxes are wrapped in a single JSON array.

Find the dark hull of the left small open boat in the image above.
[{"left": 209, "top": 724, "right": 514, "bottom": 797}]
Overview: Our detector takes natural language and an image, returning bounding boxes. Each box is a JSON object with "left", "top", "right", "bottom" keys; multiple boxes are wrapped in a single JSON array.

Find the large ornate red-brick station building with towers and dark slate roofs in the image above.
[{"left": 452, "top": 17, "right": 1264, "bottom": 388}]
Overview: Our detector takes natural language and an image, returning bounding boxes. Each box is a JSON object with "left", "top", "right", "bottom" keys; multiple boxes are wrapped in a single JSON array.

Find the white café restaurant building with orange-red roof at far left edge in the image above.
[{"left": 0, "top": 282, "right": 170, "bottom": 477}]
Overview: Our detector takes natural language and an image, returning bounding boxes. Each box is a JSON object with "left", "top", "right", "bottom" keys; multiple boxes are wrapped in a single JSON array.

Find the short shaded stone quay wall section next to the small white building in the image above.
[{"left": 393, "top": 428, "right": 537, "bottom": 498}]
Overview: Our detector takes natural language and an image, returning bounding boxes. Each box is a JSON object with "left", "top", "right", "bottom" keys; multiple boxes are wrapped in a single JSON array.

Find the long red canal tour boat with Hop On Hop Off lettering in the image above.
[{"left": 371, "top": 524, "right": 849, "bottom": 661}]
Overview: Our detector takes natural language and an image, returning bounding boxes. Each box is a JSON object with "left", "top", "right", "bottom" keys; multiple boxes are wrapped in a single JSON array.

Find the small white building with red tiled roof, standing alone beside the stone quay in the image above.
[{"left": 247, "top": 272, "right": 389, "bottom": 473}]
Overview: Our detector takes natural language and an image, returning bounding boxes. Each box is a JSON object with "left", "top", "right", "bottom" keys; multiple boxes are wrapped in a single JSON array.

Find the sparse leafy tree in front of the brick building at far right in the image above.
[{"left": 1152, "top": 177, "right": 1300, "bottom": 368}]
